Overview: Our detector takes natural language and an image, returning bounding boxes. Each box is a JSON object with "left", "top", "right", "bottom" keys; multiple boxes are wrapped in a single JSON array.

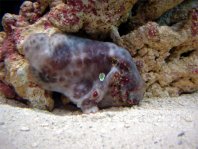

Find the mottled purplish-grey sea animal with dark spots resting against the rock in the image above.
[{"left": 24, "top": 33, "right": 144, "bottom": 113}]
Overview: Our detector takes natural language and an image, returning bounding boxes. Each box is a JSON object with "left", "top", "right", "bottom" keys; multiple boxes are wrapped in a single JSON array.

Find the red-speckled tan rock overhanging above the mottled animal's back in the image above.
[{"left": 48, "top": 0, "right": 137, "bottom": 34}]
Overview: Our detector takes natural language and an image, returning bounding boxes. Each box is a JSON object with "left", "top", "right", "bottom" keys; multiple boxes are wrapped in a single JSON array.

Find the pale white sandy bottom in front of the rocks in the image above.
[{"left": 0, "top": 93, "right": 198, "bottom": 149}]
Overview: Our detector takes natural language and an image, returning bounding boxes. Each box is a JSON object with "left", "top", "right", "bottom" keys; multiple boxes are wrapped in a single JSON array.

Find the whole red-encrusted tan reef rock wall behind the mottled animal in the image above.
[{"left": 0, "top": 0, "right": 198, "bottom": 110}]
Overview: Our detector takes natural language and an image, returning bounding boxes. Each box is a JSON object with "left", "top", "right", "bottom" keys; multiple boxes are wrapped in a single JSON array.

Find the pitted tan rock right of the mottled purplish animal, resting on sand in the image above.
[{"left": 113, "top": 9, "right": 198, "bottom": 97}]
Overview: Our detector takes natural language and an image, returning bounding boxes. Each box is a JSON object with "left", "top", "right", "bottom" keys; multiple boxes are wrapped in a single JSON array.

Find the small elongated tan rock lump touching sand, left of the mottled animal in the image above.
[{"left": 5, "top": 54, "right": 54, "bottom": 110}]
